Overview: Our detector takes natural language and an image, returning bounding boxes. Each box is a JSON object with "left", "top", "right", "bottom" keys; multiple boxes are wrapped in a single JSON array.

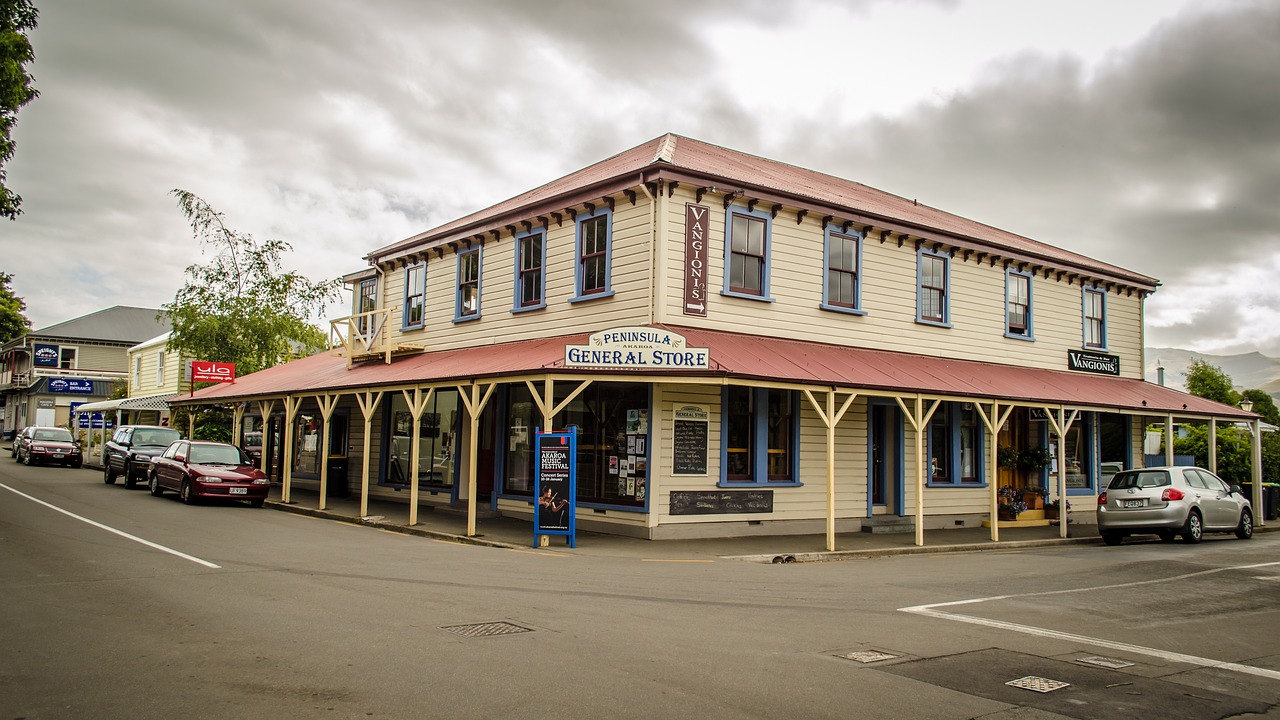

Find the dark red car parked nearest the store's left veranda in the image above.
[{"left": 147, "top": 439, "right": 270, "bottom": 507}]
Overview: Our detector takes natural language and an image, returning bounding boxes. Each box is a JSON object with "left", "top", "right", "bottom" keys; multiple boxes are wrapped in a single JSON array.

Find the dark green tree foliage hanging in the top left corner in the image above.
[{"left": 0, "top": 0, "right": 40, "bottom": 220}]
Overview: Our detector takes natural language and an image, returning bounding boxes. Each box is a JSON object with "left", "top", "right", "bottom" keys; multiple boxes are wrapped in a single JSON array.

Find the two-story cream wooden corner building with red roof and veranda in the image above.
[{"left": 172, "top": 135, "right": 1254, "bottom": 546}]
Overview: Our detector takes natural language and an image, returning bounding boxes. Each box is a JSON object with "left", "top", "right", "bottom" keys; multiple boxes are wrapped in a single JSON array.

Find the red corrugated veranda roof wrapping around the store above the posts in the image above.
[{"left": 180, "top": 325, "right": 1254, "bottom": 419}]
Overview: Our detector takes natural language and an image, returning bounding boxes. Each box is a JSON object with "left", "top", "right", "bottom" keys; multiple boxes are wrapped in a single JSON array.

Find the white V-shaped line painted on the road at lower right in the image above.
[{"left": 899, "top": 562, "right": 1280, "bottom": 680}]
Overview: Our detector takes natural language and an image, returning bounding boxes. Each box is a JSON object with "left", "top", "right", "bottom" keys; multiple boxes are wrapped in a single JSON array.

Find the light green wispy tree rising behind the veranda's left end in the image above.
[{"left": 161, "top": 190, "right": 340, "bottom": 375}]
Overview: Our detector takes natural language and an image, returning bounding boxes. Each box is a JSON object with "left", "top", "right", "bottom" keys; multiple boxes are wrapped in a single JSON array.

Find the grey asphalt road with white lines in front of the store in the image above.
[{"left": 0, "top": 452, "right": 1280, "bottom": 720}]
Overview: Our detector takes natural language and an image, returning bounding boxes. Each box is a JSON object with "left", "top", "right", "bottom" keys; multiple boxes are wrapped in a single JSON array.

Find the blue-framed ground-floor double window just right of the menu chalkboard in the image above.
[{"left": 721, "top": 386, "right": 800, "bottom": 486}]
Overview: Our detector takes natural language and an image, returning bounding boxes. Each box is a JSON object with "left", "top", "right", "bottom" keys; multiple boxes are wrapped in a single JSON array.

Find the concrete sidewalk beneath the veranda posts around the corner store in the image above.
[{"left": 268, "top": 486, "right": 1101, "bottom": 562}]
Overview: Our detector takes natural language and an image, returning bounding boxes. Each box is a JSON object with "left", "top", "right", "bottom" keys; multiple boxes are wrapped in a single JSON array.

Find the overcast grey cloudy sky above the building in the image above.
[{"left": 0, "top": 0, "right": 1280, "bottom": 356}]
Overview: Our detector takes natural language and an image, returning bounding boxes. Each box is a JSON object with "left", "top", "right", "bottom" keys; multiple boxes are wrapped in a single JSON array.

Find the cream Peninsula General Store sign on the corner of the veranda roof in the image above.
[{"left": 564, "top": 327, "right": 710, "bottom": 370}]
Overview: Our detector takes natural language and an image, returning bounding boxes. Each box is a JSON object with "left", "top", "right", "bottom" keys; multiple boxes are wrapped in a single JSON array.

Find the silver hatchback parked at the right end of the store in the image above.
[{"left": 1098, "top": 468, "right": 1253, "bottom": 544}]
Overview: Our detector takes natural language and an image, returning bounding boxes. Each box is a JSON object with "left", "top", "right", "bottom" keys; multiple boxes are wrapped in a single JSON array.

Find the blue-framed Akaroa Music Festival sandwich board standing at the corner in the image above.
[{"left": 534, "top": 425, "right": 577, "bottom": 547}]
